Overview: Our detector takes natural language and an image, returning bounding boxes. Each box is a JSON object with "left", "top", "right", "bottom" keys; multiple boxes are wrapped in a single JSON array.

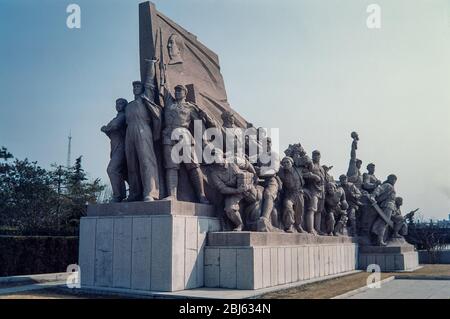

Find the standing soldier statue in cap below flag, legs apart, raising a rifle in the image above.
[{"left": 162, "top": 83, "right": 216, "bottom": 204}]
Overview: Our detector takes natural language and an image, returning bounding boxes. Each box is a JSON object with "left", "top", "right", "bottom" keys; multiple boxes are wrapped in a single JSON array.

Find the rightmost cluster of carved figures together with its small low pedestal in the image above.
[{"left": 339, "top": 132, "right": 419, "bottom": 271}]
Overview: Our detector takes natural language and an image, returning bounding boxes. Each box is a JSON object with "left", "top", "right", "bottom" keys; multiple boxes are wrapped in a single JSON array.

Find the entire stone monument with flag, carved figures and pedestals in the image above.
[{"left": 79, "top": 2, "right": 417, "bottom": 293}]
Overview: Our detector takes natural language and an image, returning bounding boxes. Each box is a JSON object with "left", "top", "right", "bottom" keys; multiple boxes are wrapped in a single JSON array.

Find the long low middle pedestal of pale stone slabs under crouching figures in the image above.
[{"left": 204, "top": 232, "right": 358, "bottom": 289}]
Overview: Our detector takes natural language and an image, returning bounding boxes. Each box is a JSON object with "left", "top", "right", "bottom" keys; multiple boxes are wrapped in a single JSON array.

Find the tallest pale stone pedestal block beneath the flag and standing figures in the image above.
[{"left": 79, "top": 200, "right": 220, "bottom": 291}]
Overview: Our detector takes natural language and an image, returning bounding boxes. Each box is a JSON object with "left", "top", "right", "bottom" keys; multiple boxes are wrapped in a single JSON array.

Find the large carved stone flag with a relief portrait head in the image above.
[{"left": 139, "top": 2, "right": 247, "bottom": 128}]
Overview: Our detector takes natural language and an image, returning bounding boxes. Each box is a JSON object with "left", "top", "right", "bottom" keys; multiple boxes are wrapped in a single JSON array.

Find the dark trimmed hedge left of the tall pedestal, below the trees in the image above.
[{"left": 0, "top": 236, "right": 78, "bottom": 277}]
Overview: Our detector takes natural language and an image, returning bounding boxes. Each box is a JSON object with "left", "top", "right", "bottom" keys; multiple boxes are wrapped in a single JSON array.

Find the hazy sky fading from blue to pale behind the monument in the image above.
[{"left": 0, "top": 0, "right": 450, "bottom": 218}]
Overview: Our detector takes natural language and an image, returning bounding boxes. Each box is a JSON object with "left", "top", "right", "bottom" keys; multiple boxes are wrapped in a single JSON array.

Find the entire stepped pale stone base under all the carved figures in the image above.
[{"left": 79, "top": 200, "right": 418, "bottom": 292}]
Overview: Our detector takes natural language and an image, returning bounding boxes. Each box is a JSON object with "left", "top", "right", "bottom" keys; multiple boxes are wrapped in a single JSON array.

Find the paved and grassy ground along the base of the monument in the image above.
[{"left": 0, "top": 265, "right": 450, "bottom": 299}]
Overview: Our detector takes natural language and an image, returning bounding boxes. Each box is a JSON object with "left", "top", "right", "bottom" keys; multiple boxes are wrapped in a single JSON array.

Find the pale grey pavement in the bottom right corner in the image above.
[{"left": 349, "top": 279, "right": 450, "bottom": 299}]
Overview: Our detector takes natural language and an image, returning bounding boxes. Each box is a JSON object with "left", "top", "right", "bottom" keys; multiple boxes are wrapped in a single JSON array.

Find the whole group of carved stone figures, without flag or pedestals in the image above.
[{"left": 101, "top": 5, "right": 414, "bottom": 250}]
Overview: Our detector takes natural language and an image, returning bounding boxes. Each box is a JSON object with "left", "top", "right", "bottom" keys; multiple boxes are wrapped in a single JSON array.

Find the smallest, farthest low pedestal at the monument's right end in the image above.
[{"left": 358, "top": 243, "right": 419, "bottom": 272}]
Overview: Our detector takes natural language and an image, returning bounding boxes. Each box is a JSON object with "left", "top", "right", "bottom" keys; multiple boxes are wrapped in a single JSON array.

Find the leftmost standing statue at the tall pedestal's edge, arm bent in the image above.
[{"left": 101, "top": 98, "right": 128, "bottom": 203}]
